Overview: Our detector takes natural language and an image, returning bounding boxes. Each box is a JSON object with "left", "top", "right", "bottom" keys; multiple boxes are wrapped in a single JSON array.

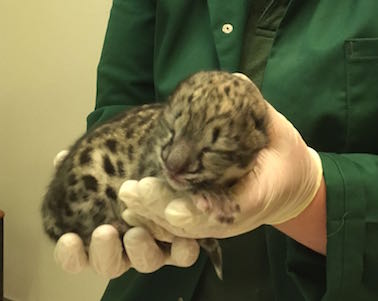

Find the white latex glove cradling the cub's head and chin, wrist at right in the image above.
[{"left": 119, "top": 99, "right": 322, "bottom": 238}]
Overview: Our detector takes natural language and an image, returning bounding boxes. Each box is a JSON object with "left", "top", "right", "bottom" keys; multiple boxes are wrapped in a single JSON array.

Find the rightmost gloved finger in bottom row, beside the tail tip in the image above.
[{"left": 166, "top": 236, "right": 200, "bottom": 267}]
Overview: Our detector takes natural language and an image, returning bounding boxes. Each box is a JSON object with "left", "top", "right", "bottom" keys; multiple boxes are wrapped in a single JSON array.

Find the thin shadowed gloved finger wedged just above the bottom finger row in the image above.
[{"left": 122, "top": 209, "right": 175, "bottom": 242}]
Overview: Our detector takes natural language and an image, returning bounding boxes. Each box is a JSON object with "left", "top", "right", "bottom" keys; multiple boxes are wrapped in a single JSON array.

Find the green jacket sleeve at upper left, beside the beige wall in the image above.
[{"left": 87, "top": 0, "right": 155, "bottom": 129}]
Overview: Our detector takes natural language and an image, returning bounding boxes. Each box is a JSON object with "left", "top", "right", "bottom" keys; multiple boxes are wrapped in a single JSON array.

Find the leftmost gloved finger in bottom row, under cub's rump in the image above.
[{"left": 54, "top": 233, "right": 88, "bottom": 273}]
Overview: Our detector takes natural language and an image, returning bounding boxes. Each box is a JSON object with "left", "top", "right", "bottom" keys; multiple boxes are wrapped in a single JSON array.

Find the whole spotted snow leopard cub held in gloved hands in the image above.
[{"left": 42, "top": 71, "right": 268, "bottom": 271}]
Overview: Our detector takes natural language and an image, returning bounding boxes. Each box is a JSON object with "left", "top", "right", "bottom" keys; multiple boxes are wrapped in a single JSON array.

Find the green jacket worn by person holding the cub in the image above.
[{"left": 88, "top": 0, "right": 378, "bottom": 301}]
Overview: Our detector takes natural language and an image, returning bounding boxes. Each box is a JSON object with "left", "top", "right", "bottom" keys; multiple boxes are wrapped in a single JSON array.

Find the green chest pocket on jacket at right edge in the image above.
[{"left": 344, "top": 37, "right": 378, "bottom": 154}]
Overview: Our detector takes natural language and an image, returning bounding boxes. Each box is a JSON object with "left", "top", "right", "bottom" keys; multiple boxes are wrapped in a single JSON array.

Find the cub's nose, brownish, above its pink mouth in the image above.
[{"left": 165, "top": 141, "right": 190, "bottom": 174}]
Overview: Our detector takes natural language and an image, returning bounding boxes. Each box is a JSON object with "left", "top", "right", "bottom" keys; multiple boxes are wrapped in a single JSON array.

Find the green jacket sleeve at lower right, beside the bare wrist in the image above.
[{"left": 320, "top": 153, "right": 378, "bottom": 300}]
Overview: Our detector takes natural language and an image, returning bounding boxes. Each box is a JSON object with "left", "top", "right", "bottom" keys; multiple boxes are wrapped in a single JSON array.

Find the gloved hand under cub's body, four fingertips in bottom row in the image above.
[{"left": 54, "top": 151, "right": 199, "bottom": 278}]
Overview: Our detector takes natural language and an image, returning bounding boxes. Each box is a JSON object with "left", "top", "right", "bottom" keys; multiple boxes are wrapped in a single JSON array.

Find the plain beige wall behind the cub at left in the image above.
[{"left": 0, "top": 0, "right": 111, "bottom": 301}]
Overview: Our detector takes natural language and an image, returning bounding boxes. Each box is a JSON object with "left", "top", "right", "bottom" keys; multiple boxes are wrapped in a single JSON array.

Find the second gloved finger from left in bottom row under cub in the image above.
[{"left": 89, "top": 225, "right": 131, "bottom": 278}]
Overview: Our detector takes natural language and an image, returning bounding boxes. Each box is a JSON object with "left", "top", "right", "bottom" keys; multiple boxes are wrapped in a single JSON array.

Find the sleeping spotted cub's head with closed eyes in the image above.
[{"left": 158, "top": 71, "right": 268, "bottom": 190}]
